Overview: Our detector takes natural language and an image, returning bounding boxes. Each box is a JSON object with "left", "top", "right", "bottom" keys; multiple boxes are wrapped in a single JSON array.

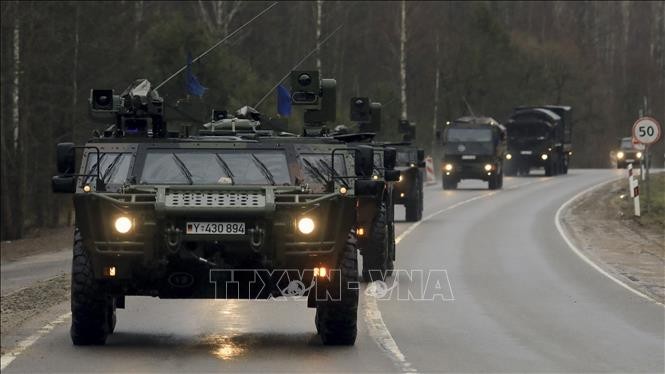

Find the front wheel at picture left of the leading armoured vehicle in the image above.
[{"left": 69, "top": 229, "right": 116, "bottom": 345}]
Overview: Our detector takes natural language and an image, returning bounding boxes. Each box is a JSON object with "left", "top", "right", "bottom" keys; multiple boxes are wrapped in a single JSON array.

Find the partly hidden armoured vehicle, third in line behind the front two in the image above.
[{"left": 389, "top": 120, "right": 425, "bottom": 222}]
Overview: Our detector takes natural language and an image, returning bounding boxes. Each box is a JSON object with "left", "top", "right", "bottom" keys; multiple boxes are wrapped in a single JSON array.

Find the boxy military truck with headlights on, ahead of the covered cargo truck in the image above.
[{"left": 441, "top": 116, "right": 506, "bottom": 190}]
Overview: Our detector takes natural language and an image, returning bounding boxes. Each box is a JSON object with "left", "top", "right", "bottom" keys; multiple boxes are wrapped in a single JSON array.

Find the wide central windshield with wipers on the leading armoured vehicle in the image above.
[{"left": 140, "top": 150, "right": 291, "bottom": 185}]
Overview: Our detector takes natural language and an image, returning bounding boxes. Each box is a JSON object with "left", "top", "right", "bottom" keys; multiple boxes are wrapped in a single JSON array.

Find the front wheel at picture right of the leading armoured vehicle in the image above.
[{"left": 314, "top": 233, "right": 358, "bottom": 345}]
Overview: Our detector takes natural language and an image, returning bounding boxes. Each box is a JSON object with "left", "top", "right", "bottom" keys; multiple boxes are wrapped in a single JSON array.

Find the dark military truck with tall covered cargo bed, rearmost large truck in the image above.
[{"left": 505, "top": 105, "right": 573, "bottom": 176}]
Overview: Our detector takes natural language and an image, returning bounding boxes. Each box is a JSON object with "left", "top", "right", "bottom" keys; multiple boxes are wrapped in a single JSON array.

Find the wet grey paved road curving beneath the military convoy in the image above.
[{"left": 3, "top": 170, "right": 665, "bottom": 373}]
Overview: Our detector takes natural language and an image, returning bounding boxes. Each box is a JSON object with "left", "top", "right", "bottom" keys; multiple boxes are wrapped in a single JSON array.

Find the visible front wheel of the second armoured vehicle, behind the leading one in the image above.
[{"left": 362, "top": 201, "right": 392, "bottom": 282}]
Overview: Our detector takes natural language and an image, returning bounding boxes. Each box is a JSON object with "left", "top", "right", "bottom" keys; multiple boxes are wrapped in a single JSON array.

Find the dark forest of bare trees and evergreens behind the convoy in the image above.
[{"left": 0, "top": 1, "right": 665, "bottom": 240}]
